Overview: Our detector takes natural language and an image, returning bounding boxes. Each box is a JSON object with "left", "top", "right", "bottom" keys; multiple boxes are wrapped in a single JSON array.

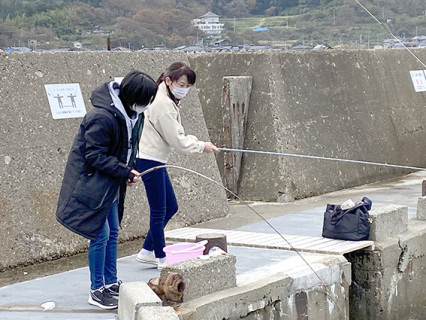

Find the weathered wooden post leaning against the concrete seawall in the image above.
[{"left": 221, "top": 76, "right": 253, "bottom": 196}]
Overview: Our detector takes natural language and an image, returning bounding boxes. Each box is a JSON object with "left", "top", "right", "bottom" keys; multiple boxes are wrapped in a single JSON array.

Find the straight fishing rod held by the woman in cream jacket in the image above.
[{"left": 218, "top": 148, "right": 426, "bottom": 171}]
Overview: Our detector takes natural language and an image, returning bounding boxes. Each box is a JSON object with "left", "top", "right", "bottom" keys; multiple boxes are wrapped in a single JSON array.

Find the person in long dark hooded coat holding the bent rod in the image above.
[{"left": 56, "top": 71, "right": 157, "bottom": 309}]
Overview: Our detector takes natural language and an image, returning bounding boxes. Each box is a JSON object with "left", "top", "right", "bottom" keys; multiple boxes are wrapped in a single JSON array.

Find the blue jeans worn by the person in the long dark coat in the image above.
[{"left": 89, "top": 201, "right": 120, "bottom": 290}]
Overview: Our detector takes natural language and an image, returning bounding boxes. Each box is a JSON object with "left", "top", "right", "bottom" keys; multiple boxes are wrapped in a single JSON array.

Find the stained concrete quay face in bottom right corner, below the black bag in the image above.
[{"left": 346, "top": 220, "right": 426, "bottom": 320}]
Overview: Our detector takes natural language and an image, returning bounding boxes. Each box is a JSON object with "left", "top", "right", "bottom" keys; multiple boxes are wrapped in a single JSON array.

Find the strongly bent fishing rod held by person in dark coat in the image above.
[{"left": 139, "top": 166, "right": 343, "bottom": 313}]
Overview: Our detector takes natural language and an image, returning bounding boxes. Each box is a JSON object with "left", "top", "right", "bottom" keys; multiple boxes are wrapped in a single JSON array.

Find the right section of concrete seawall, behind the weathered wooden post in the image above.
[{"left": 189, "top": 50, "right": 426, "bottom": 201}]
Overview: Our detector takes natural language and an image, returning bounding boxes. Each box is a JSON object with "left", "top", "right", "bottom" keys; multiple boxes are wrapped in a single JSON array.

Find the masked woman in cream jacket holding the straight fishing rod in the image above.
[{"left": 136, "top": 62, "right": 218, "bottom": 269}]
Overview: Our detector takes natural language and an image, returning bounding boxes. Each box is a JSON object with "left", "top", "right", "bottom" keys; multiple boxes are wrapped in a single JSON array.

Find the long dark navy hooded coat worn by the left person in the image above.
[{"left": 56, "top": 83, "right": 131, "bottom": 240}]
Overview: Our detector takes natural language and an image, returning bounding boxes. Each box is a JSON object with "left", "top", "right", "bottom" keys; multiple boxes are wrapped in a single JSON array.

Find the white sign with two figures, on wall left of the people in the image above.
[{"left": 45, "top": 83, "right": 86, "bottom": 119}]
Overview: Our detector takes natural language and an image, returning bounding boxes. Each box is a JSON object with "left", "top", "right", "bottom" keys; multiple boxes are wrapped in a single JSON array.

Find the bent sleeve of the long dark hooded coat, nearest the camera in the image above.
[{"left": 84, "top": 115, "right": 130, "bottom": 178}]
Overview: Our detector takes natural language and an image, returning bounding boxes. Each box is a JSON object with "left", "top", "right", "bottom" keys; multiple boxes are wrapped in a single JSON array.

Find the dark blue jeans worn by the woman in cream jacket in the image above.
[{"left": 136, "top": 159, "right": 178, "bottom": 258}]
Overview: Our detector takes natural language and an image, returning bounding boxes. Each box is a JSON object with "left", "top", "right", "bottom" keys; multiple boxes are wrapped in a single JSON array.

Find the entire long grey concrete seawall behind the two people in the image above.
[{"left": 0, "top": 50, "right": 426, "bottom": 270}]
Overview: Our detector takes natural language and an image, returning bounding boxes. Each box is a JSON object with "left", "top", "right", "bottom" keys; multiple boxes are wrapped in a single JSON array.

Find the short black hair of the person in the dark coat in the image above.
[{"left": 119, "top": 70, "right": 158, "bottom": 107}]
